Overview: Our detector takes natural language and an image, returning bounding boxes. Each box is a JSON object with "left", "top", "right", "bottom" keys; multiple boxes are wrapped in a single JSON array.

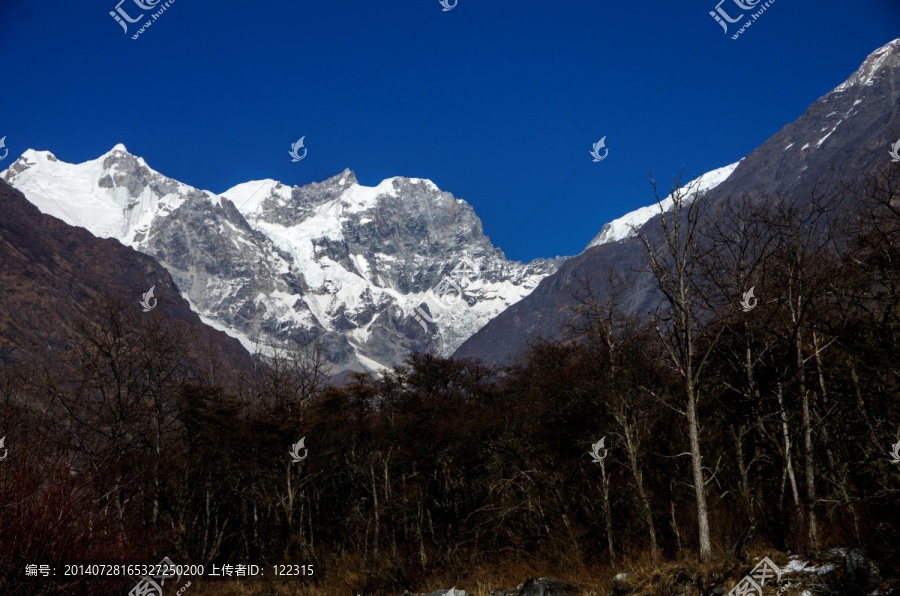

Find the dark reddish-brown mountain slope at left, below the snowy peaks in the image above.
[{"left": 0, "top": 180, "right": 252, "bottom": 380}]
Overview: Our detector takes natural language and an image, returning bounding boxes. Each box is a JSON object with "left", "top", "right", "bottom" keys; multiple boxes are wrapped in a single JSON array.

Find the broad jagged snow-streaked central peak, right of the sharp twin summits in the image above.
[{"left": 223, "top": 170, "right": 561, "bottom": 363}]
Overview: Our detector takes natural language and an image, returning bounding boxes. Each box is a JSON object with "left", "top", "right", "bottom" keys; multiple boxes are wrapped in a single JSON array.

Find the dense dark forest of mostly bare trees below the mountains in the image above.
[{"left": 0, "top": 165, "right": 900, "bottom": 595}]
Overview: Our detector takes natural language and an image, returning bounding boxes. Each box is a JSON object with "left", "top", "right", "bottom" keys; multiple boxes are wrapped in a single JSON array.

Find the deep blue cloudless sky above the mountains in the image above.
[{"left": 0, "top": 0, "right": 900, "bottom": 260}]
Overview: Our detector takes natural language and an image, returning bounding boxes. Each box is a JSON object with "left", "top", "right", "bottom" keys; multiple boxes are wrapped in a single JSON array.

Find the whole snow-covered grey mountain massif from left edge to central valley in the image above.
[{"left": 0, "top": 144, "right": 564, "bottom": 370}]
